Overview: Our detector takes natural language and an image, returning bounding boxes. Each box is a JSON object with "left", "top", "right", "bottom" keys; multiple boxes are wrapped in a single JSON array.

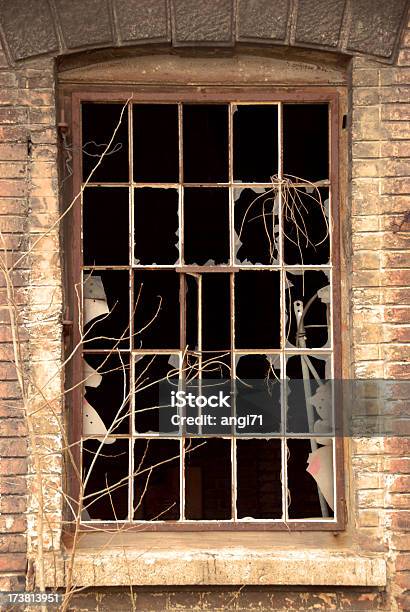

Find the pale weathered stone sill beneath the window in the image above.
[{"left": 47, "top": 533, "right": 386, "bottom": 587}]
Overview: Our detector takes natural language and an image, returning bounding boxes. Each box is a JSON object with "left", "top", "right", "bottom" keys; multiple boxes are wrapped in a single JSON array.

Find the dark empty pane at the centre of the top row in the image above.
[{"left": 183, "top": 104, "right": 229, "bottom": 183}]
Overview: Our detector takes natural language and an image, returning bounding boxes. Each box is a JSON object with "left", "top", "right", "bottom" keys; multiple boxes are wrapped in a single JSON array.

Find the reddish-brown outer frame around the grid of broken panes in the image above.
[{"left": 62, "top": 85, "right": 346, "bottom": 532}]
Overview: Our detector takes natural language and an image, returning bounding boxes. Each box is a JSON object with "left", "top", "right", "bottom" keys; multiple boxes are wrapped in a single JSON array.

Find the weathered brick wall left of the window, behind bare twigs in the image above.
[{"left": 0, "top": 37, "right": 61, "bottom": 590}]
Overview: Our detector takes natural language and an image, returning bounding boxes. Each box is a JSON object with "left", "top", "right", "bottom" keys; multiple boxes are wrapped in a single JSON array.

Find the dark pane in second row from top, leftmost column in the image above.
[{"left": 83, "top": 187, "right": 129, "bottom": 266}]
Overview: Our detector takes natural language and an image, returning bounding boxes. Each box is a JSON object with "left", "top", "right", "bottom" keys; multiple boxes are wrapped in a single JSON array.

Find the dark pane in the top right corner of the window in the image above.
[{"left": 283, "top": 104, "right": 329, "bottom": 181}]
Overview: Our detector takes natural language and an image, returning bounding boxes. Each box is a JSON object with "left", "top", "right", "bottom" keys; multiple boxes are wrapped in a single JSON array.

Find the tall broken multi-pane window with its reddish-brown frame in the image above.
[{"left": 66, "top": 91, "right": 342, "bottom": 530}]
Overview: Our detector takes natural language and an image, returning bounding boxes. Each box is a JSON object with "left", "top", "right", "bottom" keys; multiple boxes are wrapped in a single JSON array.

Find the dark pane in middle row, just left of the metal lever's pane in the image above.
[{"left": 235, "top": 270, "right": 280, "bottom": 349}]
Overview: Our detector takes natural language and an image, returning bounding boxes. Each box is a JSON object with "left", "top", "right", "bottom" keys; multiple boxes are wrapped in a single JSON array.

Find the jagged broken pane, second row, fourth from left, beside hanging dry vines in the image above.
[{"left": 234, "top": 187, "right": 279, "bottom": 265}]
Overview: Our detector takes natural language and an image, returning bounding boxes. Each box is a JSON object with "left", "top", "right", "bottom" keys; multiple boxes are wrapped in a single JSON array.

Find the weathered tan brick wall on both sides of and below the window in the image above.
[{"left": 0, "top": 8, "right": 410, "bottom": 612}]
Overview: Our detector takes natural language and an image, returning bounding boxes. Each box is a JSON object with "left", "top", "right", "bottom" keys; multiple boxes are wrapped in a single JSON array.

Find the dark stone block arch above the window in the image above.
[{"left": 0, "top": 0, "right": 409, "bottom": 62}]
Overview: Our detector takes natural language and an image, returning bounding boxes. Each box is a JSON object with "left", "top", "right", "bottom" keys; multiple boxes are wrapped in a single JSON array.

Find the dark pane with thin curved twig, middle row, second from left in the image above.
[{"left": 134, "top": 270, "right": 180, "bottom": 349}]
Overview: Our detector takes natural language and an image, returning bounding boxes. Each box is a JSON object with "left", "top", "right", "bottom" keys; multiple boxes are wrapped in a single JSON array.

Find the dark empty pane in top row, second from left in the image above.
[{"left": 132, "top": 104, "right": 179, "bottom": 183}]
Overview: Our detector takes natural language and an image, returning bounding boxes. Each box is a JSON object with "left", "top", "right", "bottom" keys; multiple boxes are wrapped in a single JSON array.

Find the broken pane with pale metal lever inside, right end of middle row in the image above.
[{"left": 285, "top": 270, "right": 331, "bottom": 348}]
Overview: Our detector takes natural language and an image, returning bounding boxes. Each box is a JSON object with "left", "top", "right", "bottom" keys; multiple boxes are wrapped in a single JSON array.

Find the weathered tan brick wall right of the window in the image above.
[{"left": 351, "top": 22, "right": 410, "bottom": 609}]
